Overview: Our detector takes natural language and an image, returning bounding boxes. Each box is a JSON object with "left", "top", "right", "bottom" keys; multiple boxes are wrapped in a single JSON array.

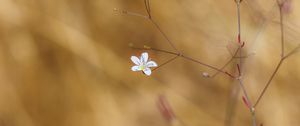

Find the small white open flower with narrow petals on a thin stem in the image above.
[{"left": 131, "top": 52, "right": 157, "bottom": 76}]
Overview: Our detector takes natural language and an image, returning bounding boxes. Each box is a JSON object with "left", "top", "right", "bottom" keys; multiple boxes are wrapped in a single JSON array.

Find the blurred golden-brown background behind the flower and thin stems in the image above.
[{"left": 0, "top": 0, "right": 300, "bottom": 126}]
